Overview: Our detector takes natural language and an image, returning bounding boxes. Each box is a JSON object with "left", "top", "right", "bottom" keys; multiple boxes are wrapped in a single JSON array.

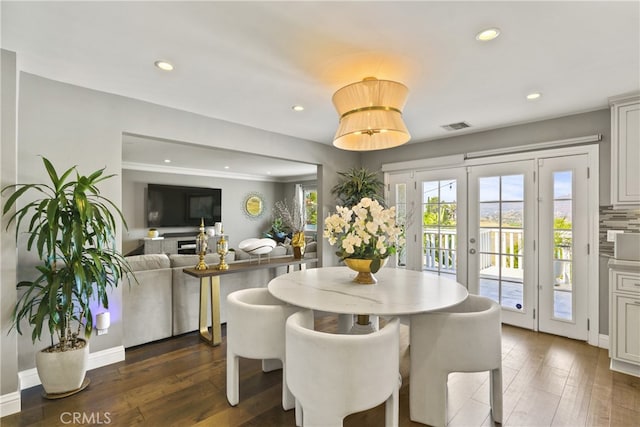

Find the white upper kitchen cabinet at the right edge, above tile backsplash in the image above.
[{"left": 609, "top": 93, "right": 640, "bottom": 208}]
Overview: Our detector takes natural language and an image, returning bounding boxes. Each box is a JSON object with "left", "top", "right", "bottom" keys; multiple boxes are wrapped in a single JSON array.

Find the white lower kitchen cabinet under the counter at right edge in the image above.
[{"left": 609, "top": 260, "right": 640, "bottom": 377}]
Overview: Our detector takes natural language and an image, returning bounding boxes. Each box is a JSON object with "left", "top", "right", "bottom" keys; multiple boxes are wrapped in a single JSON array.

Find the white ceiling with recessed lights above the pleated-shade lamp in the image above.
[{"left": 1, "top": 1, "right": 640, "bottom": 177}]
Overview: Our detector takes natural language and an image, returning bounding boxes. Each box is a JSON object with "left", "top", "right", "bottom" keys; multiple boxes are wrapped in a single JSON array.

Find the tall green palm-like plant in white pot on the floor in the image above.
[{"left": 2, "top": 158, "right": 132, "bottom": 397}]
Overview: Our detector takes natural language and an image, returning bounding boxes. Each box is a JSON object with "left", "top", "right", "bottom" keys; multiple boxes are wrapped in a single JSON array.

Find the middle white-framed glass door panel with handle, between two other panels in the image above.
[{"left": 469, "top": 161, "right": 535, "bottom": 328}]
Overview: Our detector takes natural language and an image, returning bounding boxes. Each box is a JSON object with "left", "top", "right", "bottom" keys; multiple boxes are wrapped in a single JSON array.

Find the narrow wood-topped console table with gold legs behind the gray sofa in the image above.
[{"left": 182, "top": 256, "right": 318, "bottom": 346}]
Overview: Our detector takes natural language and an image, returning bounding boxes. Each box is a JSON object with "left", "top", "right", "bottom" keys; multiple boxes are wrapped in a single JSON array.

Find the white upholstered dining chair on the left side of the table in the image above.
[{"left": 227, "top": 288, "right": 301, "bottom": 410}]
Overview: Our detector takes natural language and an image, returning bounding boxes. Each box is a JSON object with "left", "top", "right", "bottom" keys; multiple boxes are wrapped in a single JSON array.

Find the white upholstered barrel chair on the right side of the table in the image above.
[{"left": 409, "top": 295, "right": 502, "bottom": 426}]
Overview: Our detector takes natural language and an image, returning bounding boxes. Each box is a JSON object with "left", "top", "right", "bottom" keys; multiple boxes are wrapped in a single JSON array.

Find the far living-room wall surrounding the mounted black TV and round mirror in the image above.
[{"left": 122, "top": 170, "right": 286, "bottom": 253}]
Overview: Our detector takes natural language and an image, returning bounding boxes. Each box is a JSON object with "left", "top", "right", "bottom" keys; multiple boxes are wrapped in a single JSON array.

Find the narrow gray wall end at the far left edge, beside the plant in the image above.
[{"left": 0, "top": 50, "right": 18, "bottom": 402}]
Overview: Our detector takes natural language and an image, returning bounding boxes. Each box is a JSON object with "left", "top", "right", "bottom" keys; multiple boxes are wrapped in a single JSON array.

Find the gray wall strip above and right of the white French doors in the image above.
[{"left": 362, "top": 109, "right": 611, "bottom": 335}]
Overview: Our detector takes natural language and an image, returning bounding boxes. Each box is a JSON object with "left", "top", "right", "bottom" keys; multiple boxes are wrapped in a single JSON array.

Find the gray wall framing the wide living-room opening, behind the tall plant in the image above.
[{"left": 10, "top": 73, "right": 359, "bottom": 370}]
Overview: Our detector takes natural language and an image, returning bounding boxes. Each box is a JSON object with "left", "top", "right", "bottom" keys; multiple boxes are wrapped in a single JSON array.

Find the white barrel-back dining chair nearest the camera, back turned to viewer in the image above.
[{"left": 286, "top": 310, "right": 400, "bottom": 427}]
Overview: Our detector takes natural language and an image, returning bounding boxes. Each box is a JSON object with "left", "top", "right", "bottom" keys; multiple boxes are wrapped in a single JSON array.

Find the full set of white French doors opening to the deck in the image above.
[{"left": 386, "top": 149, "right": 598, "bottom": 342}]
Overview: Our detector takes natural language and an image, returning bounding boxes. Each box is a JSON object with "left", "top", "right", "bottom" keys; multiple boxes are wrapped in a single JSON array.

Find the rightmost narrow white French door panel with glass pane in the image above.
[{"left": 538, "top": 154, "right": 591, "bottom": 340}]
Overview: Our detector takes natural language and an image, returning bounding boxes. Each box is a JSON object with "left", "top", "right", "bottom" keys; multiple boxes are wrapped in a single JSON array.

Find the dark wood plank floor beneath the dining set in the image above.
[{"left": 0, "top": 319, "right": 640, "bottom": 427}]
